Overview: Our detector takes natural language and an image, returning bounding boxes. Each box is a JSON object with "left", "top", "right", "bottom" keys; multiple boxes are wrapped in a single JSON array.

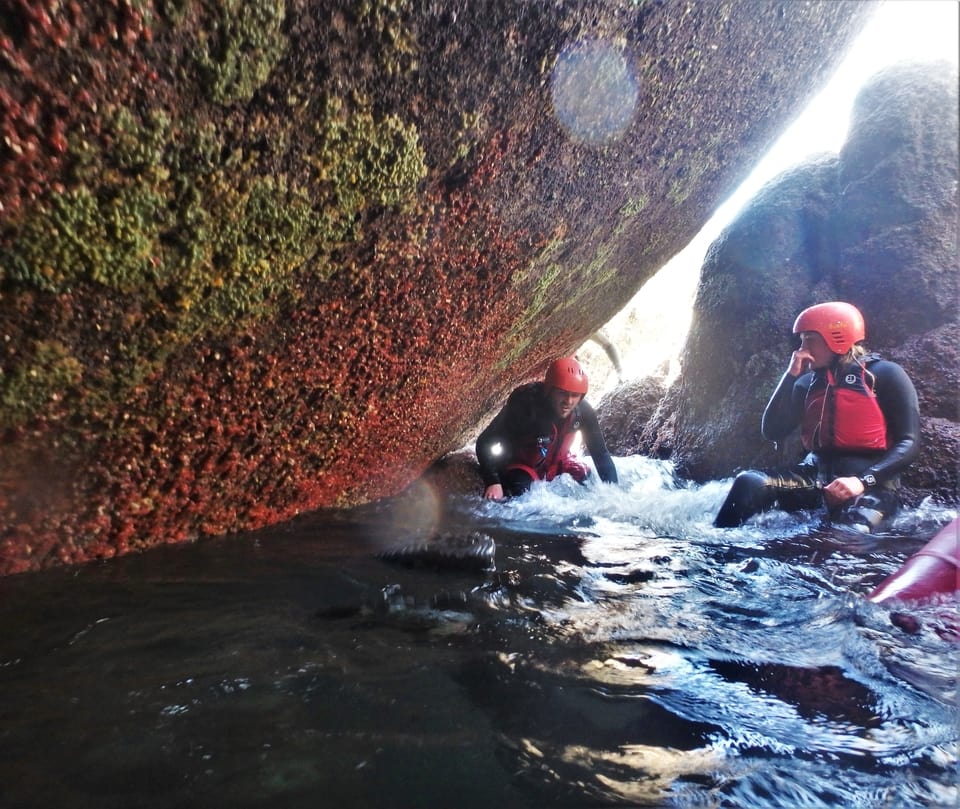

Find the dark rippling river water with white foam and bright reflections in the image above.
[{"left": 0, "top": 458, "right": 960, "bottom": 809}]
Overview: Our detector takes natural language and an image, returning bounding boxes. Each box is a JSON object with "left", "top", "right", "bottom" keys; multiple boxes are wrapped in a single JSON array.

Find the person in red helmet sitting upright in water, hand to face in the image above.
[{"left": 713, "top": 301, "right": 920, "bottom": 533}]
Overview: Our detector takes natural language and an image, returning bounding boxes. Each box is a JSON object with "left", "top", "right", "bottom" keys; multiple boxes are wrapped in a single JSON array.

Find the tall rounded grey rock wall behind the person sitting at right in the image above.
[{"left": 628, "top": 63, "right": 960, "bottom": 503}]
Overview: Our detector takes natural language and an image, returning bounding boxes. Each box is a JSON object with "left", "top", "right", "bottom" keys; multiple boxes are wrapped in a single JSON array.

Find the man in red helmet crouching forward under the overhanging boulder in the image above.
[{"left": 477, "top": 357, "right": 617, "bottom": 500}]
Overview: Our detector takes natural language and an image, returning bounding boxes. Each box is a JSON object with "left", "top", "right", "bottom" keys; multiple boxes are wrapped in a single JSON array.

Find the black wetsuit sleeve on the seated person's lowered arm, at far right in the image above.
[{"left": 861, "top": 360, "right": 920, "bottom": 483}]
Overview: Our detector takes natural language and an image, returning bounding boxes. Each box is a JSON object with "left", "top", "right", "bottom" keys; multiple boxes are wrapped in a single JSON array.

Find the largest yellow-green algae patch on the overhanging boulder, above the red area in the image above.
[{"left": 0, "top": 94, "right": 427, "bottom": 318}]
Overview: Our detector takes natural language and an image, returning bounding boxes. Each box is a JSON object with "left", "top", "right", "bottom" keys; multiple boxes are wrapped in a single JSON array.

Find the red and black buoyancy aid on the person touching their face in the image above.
[{"left": 801, "top": 355, "right": 888, "bottom": 452}]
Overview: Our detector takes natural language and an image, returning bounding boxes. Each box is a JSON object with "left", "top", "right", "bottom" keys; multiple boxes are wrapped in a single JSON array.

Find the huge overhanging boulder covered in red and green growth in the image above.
[{"left": 0, "top": 0, "right": 872, "bottom": 573}]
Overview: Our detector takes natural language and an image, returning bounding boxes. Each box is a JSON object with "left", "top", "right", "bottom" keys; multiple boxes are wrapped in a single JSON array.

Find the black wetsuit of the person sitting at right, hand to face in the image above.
[{"left": 714, "top": 355, "right": 920, "bottom": 531}]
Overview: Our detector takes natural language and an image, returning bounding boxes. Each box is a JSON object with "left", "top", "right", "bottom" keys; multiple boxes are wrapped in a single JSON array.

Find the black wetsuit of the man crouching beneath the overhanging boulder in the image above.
[{"left": 477, "top": 382, "right": 617, "bottom": 496}]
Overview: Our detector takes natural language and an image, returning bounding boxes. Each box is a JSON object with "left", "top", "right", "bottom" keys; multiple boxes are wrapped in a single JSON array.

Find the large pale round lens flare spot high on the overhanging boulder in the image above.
[{"left": 551, "top": 40, "right": 639, "bottom": 144}]
